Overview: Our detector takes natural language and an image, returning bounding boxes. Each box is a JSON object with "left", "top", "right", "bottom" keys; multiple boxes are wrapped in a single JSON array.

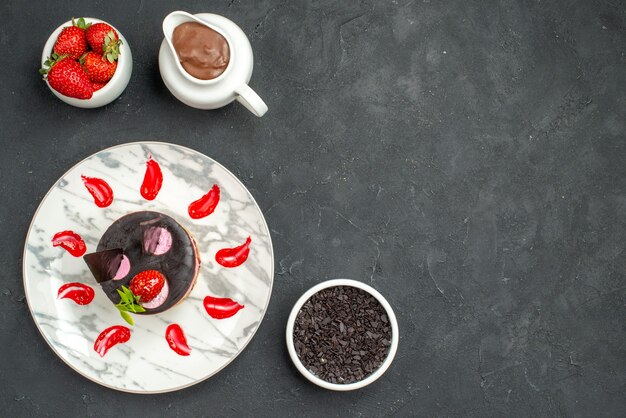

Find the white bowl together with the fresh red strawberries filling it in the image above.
[{"left": 40, "top": 17, "right": 133, "bottom": 108}]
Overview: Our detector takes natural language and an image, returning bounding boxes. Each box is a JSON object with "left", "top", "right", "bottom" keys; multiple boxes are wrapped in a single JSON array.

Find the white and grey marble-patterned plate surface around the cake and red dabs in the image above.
[{"left": 23, "top": 142, "right": 274, "bottom": 393}]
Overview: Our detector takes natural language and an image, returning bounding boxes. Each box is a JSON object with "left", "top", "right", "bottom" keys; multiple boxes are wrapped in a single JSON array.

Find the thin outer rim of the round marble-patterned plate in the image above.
[{"left": 22, "top": 141, "right": 275, "bottom": 395}]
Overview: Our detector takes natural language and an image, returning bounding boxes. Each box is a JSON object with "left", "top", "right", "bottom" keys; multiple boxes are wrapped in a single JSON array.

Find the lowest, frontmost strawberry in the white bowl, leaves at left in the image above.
[{"left": 39, "top": 54, "right": 93, "bottom": 99}]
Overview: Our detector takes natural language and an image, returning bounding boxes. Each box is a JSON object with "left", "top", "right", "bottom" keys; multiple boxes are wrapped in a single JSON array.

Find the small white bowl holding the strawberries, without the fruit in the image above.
[{"left": 41, "top": 17, "right": 133, "bottom": 109}]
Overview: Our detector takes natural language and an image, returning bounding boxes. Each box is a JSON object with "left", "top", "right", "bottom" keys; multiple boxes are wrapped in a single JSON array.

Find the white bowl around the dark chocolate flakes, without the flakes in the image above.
[{"left": 286, "top": 279, "right": 400, "bottom": 391}]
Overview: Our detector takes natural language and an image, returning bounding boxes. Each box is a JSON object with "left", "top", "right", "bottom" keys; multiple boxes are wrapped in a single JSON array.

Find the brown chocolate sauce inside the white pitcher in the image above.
[{"left": 172, "top": 22, "right": 230, "bottom": 80}]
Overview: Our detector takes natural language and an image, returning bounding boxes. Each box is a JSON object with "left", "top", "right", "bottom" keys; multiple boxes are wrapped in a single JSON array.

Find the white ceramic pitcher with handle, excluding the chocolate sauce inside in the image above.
[{"left": 159, "top": 11, "right": 267, "bottom": 116}]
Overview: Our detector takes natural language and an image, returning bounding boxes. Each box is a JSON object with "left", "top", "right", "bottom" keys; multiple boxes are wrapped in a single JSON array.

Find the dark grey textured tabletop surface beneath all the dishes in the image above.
[{"left": 0, "top": 0, "right": 626, "bottom": 417}]
